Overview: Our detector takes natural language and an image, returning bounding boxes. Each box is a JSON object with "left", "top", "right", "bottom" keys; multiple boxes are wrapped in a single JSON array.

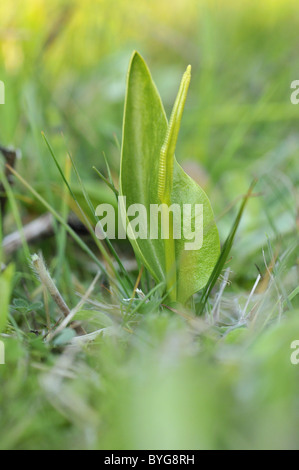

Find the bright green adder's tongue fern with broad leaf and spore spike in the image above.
[{"left": 120, "top": 52, "right": 220, "bottom": 303}]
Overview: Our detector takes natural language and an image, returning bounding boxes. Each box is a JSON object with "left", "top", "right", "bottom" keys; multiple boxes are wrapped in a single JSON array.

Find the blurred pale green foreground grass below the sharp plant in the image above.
[{"left": 0, "top": 311, "right": 299, "bottom": 450}]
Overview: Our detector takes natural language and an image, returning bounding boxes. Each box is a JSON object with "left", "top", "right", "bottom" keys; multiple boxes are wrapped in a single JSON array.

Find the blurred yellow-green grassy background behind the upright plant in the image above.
[{"left": 0, "top": 0, "right": 299, "bottom": 275}]
